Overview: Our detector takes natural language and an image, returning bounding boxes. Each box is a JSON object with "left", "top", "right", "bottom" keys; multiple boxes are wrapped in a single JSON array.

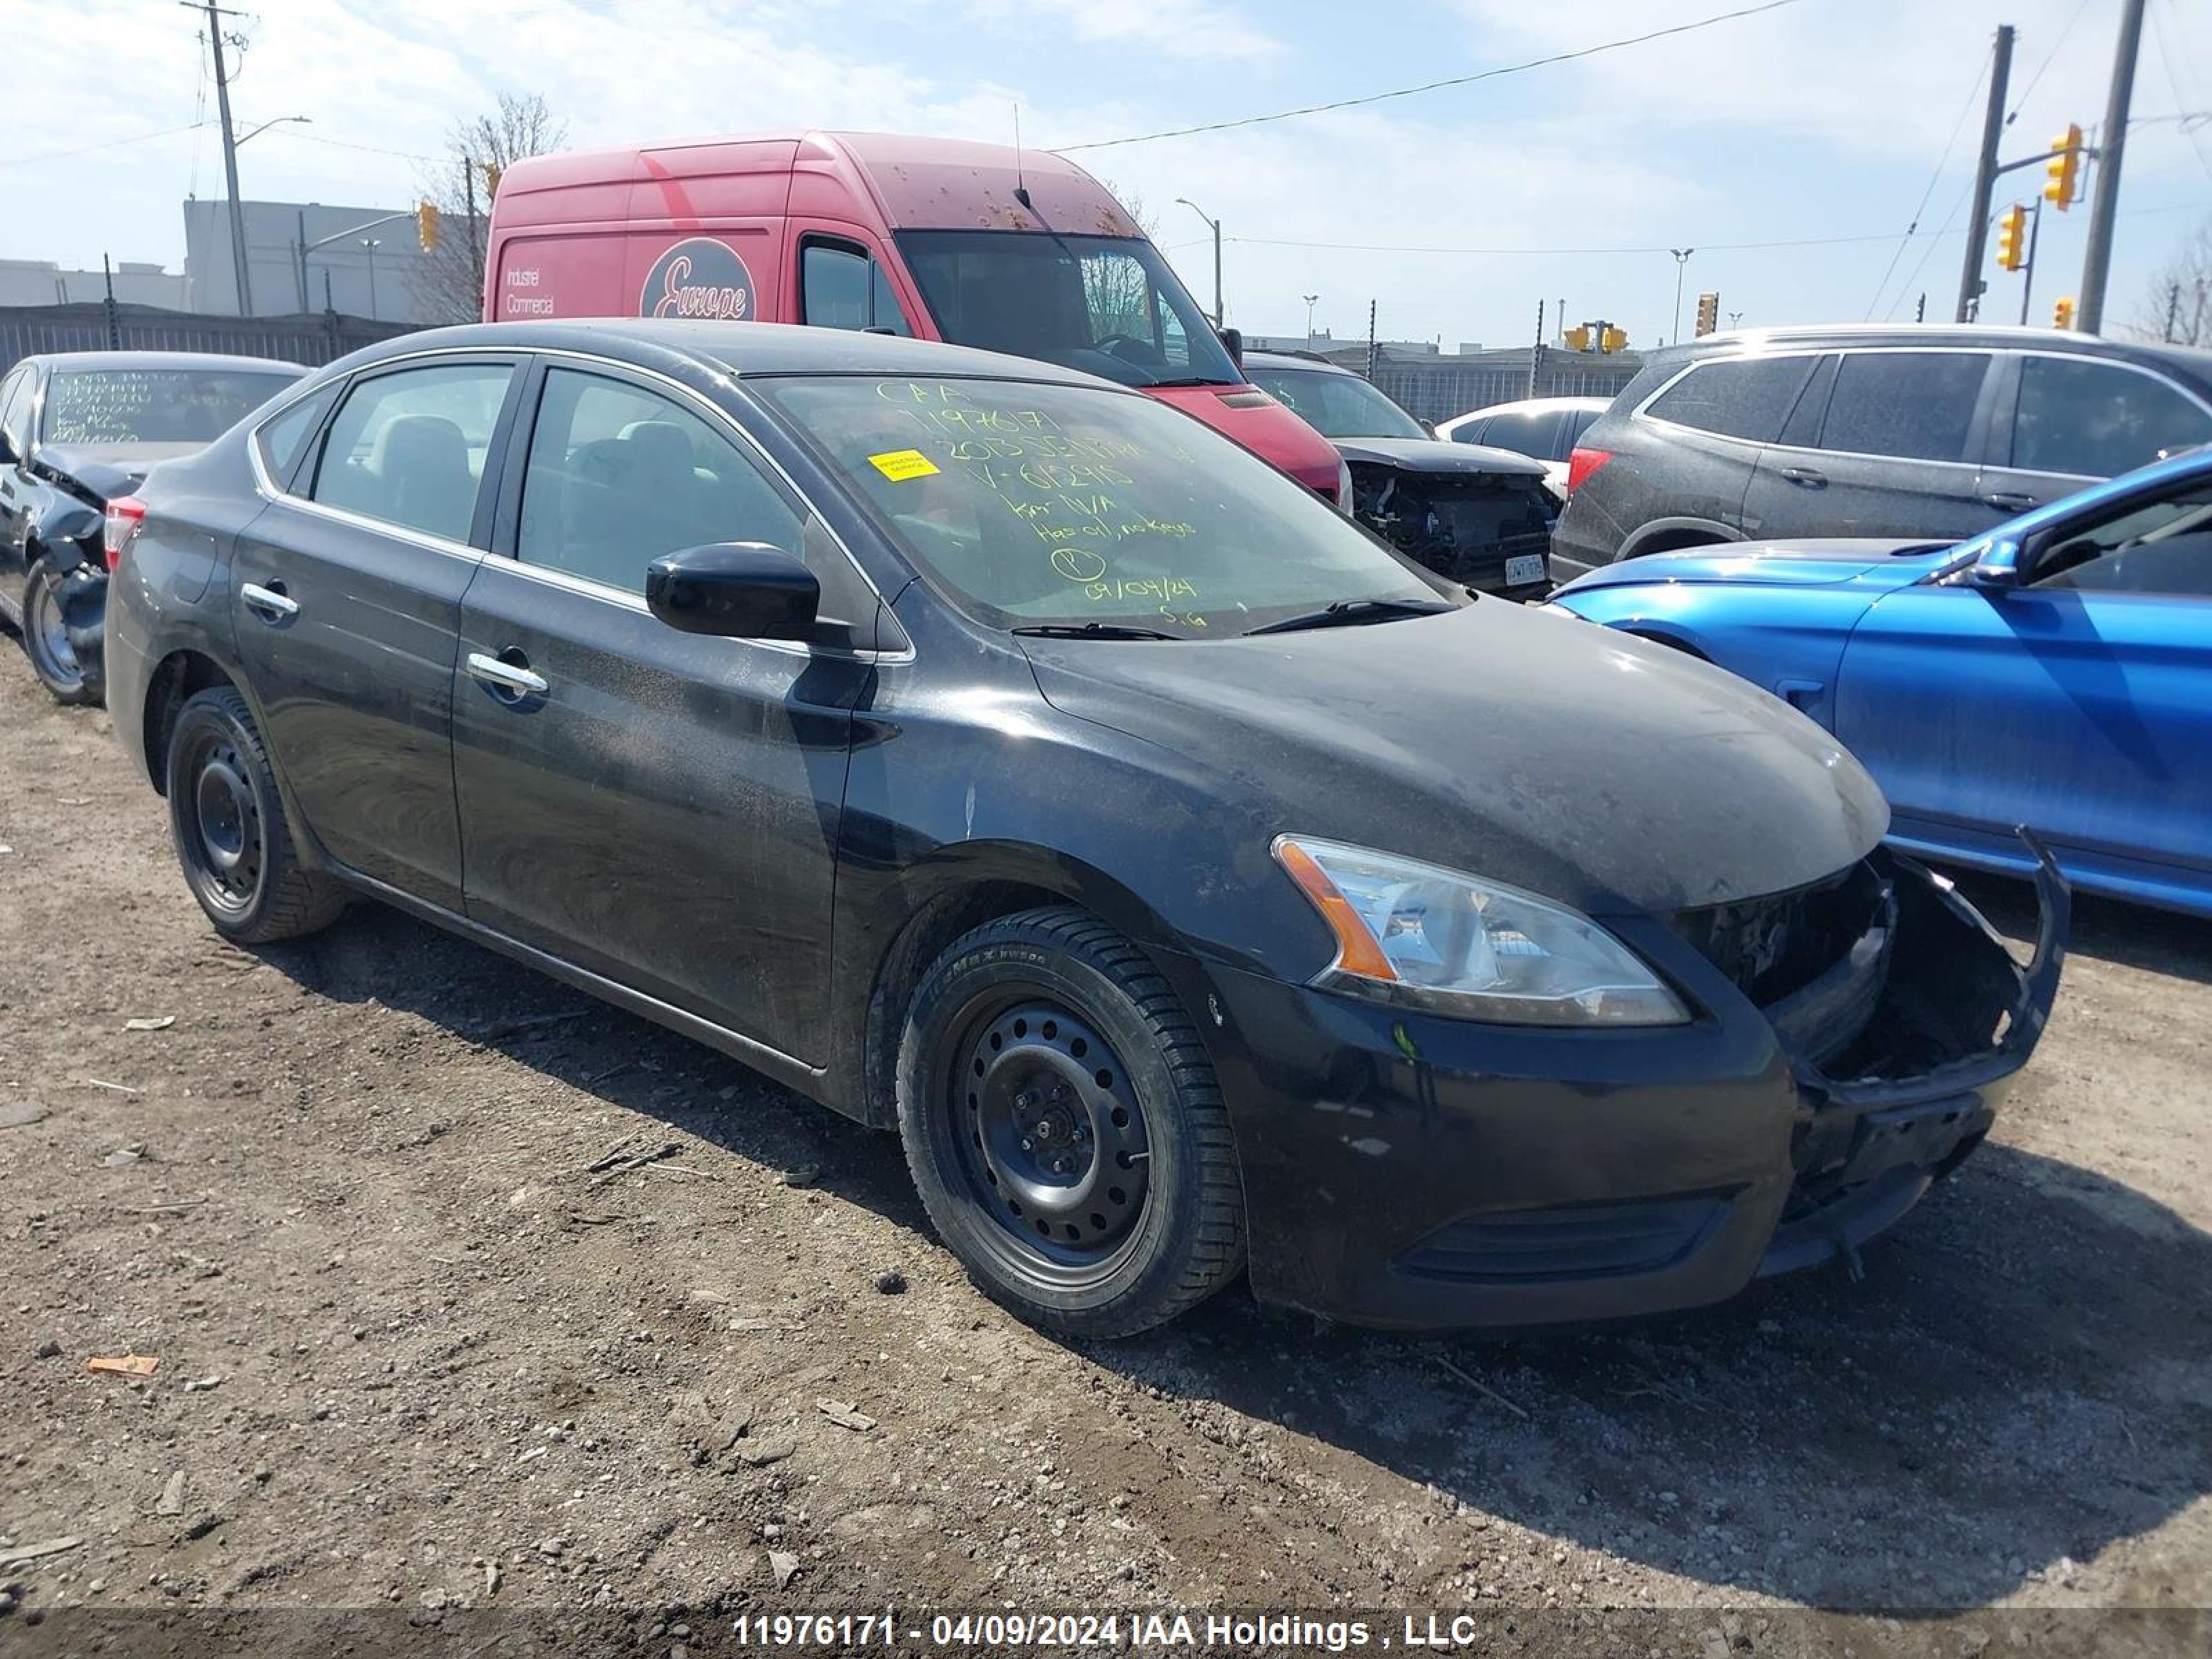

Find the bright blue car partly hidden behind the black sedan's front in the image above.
[{"left": 1553, "top": 449, "right": 2212, "bottom": 916}]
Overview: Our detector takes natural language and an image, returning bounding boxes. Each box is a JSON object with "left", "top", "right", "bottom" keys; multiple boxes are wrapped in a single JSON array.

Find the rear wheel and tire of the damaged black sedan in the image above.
[{"left": 168, "top": 686, "right": 345, "bottom": 944}]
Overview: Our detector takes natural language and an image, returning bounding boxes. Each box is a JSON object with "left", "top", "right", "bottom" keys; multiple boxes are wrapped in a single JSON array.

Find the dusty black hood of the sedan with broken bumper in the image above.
[{"left": 1022, "top": 599, "right": 1889, "bottom": 916}]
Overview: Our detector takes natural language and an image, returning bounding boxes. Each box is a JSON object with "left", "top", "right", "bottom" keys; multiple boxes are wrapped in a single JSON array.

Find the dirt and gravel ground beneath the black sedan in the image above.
[{"left": 0, "top": 641, "right": 2212, "bottom": 1655}]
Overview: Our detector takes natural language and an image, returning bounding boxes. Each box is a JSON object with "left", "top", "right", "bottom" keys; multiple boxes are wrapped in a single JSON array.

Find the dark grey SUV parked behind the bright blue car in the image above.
[{"left": 1550, "top": 328, "right": 2212, "bottom": 582}]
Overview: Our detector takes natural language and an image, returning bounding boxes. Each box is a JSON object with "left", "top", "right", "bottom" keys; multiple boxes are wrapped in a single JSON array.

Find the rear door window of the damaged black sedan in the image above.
[{"left": 308, "top": 363, "right": 513, "bottom": 542}]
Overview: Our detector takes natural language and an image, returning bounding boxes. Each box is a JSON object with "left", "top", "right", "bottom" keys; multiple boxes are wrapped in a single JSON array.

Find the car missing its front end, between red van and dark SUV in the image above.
[{"left": 1246, "top": 352, "right": 1553, "bottom": 599}]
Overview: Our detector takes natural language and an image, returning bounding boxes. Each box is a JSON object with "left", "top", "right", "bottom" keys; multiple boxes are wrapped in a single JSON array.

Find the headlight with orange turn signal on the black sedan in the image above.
[{"left": 1274, "top": 836, "right": 1690, "bottom": 1027}]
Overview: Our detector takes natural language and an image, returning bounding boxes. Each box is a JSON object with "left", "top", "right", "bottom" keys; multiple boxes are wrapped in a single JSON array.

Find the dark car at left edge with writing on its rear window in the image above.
[{"left": 0, "top": 352, "right": 308, "bottom": 704}]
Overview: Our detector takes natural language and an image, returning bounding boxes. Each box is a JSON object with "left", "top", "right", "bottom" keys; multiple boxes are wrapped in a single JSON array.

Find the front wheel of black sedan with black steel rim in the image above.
[{"left": 898, "top": 907, "right": 1246, "bottom": 1336}]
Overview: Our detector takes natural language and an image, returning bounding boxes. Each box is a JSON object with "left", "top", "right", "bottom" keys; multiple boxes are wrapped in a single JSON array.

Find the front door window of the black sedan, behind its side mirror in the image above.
[{"left": 516, "top": 369, "right": 803, "bottom": 593}]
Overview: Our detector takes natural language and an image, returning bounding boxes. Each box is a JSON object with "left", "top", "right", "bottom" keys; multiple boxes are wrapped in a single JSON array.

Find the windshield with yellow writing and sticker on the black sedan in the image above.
[{"left": 750, "top": 376, "right": 1445, "bottom": 639}]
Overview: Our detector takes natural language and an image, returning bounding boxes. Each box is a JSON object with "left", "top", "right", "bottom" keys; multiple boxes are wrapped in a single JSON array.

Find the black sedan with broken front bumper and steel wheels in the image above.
[{"left": 109, "top": 321, "right": 2064, "bottom": 1336}]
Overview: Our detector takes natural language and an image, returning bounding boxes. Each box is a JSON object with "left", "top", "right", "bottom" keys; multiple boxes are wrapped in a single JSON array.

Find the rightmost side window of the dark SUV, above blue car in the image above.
[{"left": 2013, "top": 356, "right": 2212, "bottom": 478}]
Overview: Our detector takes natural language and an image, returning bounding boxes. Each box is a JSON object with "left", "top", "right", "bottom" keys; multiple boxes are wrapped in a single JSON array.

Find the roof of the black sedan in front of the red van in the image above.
[{"left": 332, "top": 317, "right": 1137, "bottom": 396}]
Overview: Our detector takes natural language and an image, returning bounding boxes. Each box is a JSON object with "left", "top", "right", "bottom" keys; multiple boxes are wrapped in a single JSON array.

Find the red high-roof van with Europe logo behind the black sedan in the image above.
[{"left": 485, "top": 133, "right": 1349, "bottom": 505}]
